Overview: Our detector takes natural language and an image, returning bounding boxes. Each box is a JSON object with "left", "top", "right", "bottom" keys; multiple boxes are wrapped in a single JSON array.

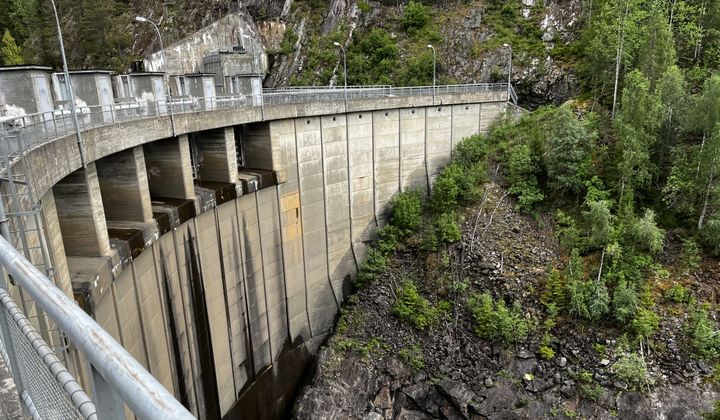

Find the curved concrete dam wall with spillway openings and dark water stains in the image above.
[{"left": 2, "top": 85, "right": 509, "bottom": 419}]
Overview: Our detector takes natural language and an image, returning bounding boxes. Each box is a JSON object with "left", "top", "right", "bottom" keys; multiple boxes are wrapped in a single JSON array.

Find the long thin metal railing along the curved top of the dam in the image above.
[{"left": 0, "top": 83, "right": 514, "bottom": 158}]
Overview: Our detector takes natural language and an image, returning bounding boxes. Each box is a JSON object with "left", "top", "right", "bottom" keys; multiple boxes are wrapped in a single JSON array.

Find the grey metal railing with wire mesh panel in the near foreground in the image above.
[{"left": 0, "top": 237, "right": 194, "bottom": 420}]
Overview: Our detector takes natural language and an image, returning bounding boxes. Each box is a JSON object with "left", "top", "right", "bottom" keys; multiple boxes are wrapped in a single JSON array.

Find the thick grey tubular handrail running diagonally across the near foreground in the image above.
[{"left": 0, "top": 237, "right": 195, "bottom": 420}]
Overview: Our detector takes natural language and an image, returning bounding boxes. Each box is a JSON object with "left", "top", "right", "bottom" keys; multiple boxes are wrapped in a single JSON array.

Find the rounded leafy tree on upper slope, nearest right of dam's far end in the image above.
[{"left": 545, "top": 106, "right": 596, "bottom": 195}]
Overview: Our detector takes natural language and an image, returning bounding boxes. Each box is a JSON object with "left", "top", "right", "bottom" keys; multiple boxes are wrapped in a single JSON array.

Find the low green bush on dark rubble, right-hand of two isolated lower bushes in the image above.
[{"left": 467, "top": 293, "right": 530, "bottom": 344}]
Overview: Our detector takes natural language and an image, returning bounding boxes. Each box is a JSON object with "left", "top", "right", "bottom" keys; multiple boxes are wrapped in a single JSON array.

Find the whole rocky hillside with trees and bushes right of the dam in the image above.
[{"left": 295, "top": 1, "right": 720, "bottom": 404}]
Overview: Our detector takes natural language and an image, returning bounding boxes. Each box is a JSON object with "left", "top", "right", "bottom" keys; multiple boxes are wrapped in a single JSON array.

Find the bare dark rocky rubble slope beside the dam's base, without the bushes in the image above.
[{"left": 295, "top": 184, "right": 719, "bottom": 420}]
